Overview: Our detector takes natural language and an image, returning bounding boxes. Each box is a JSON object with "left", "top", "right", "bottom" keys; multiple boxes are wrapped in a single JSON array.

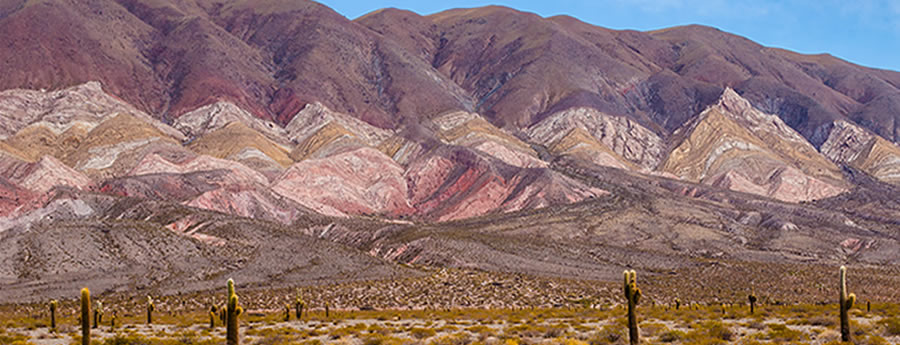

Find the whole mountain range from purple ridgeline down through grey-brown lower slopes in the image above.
[{"left": 0, "top": 0, "right": 900, "bottom": 297}]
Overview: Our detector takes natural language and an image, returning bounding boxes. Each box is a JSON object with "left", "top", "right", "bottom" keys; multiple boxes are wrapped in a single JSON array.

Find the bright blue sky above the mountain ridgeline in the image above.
[{"left": 319, "top": 0, "right": 900, "bottom": 71}]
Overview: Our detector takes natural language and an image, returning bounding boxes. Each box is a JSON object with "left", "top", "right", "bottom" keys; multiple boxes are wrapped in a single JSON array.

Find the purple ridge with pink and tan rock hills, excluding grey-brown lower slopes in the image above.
[{"left": 0, "top": 0, "right": 900, "bottom": 226}]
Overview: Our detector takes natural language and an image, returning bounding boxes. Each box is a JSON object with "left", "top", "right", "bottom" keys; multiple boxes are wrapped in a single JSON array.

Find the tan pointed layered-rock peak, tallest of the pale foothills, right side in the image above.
[{"left": 661, "top": 90, "right": 846, "bottom": 202}]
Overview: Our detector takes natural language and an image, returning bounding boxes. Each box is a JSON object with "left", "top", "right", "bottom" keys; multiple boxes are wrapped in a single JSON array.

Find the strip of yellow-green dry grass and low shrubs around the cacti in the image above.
[{"left": 0, "top": 303, "right": 900, "bottom": 345}]
